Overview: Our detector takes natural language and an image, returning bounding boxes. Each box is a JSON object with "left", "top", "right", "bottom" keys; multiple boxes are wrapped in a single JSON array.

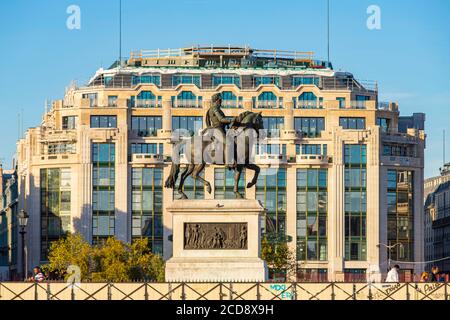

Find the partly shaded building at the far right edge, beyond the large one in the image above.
[{"left": 424, "top": 163, "right": 450, "bottom": 274}]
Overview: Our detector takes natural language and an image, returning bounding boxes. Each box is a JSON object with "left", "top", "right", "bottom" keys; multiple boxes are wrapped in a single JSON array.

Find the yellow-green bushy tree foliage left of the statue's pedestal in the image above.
[{"left": 44, "top": 234, "right": 164, "bottom": 282}]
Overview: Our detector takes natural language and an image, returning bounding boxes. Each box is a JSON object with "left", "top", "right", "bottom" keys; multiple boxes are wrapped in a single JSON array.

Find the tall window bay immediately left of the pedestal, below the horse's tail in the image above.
[{"left": 131, "top": 168, "right": 163, "bottom": 255}]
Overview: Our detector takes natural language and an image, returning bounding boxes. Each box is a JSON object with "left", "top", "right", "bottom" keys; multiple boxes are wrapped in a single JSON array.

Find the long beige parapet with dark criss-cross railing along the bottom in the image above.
[{"left": 0, "top": 282, "right": 450, "bottom": 300}]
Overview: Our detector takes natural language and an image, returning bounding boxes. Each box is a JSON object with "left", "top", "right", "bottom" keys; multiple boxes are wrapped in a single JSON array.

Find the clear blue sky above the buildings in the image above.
[{"left": 0, "top": 0, "right": 450, "bottom": 177}]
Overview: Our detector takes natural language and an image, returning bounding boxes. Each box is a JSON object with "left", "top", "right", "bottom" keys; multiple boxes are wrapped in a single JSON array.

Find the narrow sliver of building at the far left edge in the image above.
[{"left": 0, "top": 165, "right": 20, "bottom": 280}]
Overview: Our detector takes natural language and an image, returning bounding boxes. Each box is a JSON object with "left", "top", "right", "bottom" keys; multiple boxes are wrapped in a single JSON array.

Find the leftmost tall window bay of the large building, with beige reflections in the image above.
[{"left": 40, "top": 168, "right": 71, "bottom": 261}]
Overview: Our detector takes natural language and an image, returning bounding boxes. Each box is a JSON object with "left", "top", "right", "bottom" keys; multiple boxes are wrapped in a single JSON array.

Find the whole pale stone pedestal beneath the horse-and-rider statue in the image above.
[{"left": 165, "top": 200, "right": 267, "bottom": 282}]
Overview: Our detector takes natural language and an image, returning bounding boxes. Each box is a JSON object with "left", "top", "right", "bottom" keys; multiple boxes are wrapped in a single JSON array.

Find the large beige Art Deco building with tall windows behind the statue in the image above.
[{"left": 17, "top": 47, "right": 425, "bottom": 281}]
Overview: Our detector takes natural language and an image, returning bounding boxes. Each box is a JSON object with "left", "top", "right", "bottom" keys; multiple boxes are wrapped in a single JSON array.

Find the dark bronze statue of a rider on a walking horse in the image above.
[{"left": 165, "top": 93, "right": 264, "bottom": 199}]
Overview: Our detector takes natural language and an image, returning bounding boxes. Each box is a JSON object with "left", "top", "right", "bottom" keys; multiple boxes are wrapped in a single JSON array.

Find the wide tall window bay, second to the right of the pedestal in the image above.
[{"left": 297, "top": 169, "right": 328, "bottom": 261}]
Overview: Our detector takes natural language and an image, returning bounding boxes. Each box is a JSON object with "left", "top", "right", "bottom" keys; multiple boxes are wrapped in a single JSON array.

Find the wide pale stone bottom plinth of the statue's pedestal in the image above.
[{"left": 166, "top": 258, "right": 267, "bottom": 282}]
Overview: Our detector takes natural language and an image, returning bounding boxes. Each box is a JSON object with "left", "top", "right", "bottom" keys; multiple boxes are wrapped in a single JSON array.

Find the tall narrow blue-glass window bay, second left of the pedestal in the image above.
[{"left": 92, "top": 143, "right": 116, "bottom": 244}]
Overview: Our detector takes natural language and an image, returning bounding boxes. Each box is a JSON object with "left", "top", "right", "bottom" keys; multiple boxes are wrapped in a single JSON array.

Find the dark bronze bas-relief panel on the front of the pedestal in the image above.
[{"left": 184, "top": 222, "right": 248, "bottom": 250}]
